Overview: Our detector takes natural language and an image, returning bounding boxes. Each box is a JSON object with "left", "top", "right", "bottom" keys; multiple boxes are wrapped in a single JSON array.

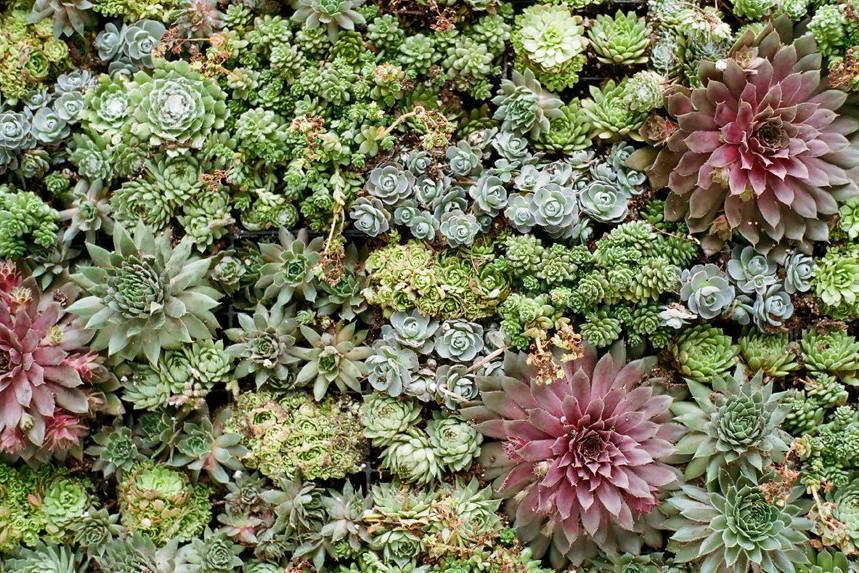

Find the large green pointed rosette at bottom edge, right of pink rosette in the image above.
[{"left": 664, "top": 472, "right": 812, "bottom": 573}]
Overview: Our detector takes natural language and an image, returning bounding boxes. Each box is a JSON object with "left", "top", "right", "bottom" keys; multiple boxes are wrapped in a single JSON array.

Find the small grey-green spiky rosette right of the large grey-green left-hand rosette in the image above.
[{"left": 256, "top": 228, "right": 324, "bottom": 305}]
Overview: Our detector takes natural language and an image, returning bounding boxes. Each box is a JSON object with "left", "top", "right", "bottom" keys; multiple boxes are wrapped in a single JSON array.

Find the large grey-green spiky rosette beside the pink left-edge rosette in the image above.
[{"left": 68, "top": 223, "right": 222, "bottom": 364}]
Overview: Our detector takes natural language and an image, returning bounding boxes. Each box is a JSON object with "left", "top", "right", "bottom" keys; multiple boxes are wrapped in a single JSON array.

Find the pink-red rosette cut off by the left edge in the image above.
[{"left": 0, "top": 280, "right": 92, "bottom": 457}]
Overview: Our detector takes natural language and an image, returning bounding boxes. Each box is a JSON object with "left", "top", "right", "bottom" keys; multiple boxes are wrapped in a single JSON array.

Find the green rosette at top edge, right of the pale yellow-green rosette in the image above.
[{"left": 588, "top": 10, "right": 650, "bottom": 66}]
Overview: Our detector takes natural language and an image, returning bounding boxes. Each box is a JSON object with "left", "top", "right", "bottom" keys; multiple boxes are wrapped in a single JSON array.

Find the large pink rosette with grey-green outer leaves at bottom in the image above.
[{"left": 462, "top": 344, "right": 679, "bottom": 566}]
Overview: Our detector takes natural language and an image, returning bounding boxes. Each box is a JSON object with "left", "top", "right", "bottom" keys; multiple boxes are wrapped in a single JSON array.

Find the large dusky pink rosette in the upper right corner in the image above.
[{"left": 650, "top": 18, "right": 859, "bottom": 260}]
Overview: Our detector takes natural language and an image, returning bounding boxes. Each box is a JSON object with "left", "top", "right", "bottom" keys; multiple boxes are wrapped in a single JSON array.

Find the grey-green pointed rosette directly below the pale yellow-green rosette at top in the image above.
[{"left": 492, "top": 70, "right": 562, "bottom": 138}]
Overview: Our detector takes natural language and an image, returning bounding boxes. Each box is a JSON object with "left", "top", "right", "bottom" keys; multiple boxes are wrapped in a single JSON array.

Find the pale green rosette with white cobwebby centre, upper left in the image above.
[{"left": 128, "top": 60, "right": 229, "bottom": 151}]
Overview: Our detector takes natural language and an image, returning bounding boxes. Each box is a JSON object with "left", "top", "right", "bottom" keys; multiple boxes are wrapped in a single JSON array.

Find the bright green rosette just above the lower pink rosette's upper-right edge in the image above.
[{"left": 671, "top": 324, "right": 737, "bottom": 383}]
